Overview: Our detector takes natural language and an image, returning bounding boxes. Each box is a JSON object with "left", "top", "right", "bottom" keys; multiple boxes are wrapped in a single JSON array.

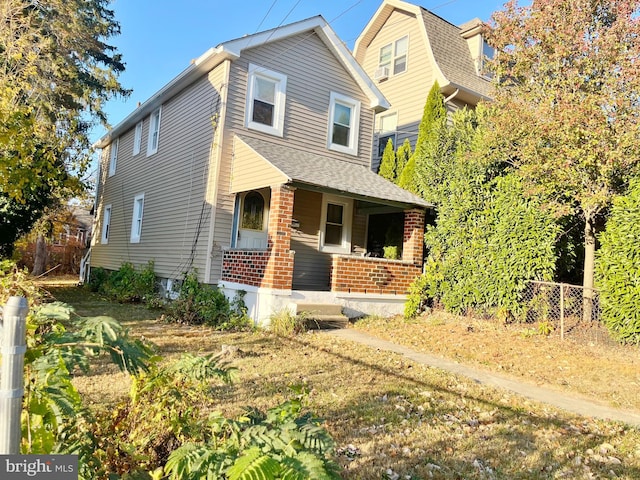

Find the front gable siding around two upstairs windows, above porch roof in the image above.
[{"left": 226, "top": 33, "right": 373, "bottom": 166}]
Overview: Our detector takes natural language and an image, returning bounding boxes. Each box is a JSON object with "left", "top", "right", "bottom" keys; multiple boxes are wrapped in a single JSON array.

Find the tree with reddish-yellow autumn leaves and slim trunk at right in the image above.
[{"left": 487, "top": 0, "right": 640, "bottom": 296}]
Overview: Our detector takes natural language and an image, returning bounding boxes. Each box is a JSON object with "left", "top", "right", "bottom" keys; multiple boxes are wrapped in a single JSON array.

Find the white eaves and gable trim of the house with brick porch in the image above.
[{"left": 94, "top": 15, "right": 389, "bottom": 148}]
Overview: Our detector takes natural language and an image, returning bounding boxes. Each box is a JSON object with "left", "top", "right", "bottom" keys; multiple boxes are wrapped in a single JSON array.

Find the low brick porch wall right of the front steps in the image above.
[{"left": 331, "top": 255, "right": 422, "bottom": 295}]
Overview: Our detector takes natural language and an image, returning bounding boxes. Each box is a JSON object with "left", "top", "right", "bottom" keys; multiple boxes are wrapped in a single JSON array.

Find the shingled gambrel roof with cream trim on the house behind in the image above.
[{"left": 353, "top": 0, "right": 491, "bottom": 99}]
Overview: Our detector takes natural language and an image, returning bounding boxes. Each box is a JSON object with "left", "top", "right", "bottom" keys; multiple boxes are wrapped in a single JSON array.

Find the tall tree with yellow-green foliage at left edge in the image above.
[{"left": 0, "top": 0, "right": 128, "bottom": 253}]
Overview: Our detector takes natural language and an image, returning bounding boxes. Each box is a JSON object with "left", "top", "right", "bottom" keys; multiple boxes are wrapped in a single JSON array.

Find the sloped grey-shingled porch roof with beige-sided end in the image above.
[{"left": 232, "top": 135, "right": 433, "bottom": 208}]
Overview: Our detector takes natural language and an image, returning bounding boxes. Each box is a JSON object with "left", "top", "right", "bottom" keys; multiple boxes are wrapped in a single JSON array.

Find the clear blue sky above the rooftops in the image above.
[{"left": 91, "top": 0, "right": 505, "bottom": 141}]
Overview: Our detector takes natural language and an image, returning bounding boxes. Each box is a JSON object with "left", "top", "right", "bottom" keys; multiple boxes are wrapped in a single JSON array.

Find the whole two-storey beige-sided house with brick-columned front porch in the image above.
[{"left": 91, "top": 17, "right": 429, "bottom": 321}]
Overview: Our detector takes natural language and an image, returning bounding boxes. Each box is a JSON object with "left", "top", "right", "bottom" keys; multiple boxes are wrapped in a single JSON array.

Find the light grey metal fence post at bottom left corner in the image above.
[{"left": 0, "top": 297, "right": 29, "bottom": 455}]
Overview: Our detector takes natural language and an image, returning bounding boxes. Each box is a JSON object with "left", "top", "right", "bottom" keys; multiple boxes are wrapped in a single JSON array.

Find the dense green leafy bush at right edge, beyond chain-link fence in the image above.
[{"left": 596, "top": 180, "right": 640, "bottom": 344}]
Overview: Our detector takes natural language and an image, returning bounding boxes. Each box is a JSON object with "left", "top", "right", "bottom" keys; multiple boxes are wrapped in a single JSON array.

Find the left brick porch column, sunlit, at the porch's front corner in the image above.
[{"left": 261, "top": 185, "right": 295, "bottom": 290}]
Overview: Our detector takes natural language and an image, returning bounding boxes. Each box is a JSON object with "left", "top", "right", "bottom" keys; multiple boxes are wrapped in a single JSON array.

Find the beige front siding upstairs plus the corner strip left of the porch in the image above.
[{"left": 208, "top": 33, "right": 374, "bottom": 285}]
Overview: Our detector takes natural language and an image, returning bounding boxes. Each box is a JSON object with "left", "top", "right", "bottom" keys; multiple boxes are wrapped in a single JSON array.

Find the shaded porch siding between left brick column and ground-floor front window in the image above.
[{"left": 291, "top": 189, "right": 331, "bottom": 290}]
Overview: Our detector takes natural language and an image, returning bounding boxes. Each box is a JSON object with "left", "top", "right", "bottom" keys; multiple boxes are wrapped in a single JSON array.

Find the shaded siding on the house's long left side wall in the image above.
[{"left": 91, "top": 69, "right": 228, "bottom": 284}]
